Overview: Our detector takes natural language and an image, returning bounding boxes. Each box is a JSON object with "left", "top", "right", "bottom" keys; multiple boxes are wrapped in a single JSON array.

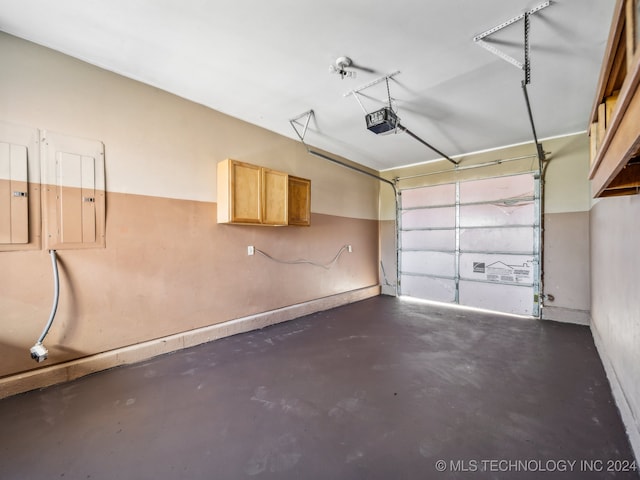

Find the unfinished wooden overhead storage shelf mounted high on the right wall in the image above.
[{"left": 589, "top": 0, "right": 640, "bottom": 197}]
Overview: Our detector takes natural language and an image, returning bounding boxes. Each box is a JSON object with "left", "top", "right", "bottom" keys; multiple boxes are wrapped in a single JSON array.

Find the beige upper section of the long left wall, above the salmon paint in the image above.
[{"left": 0, "top": 33, "right": 379, "bottom": 219}]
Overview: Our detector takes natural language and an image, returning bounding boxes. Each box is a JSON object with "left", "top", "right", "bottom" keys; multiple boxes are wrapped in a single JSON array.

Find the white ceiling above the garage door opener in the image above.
[{"left": 0, "top": 0, "right": 615, "bottom": 170}]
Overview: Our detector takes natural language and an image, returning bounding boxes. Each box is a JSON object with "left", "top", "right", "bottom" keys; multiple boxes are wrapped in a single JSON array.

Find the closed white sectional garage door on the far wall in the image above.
[{"left": 400, "top": 174, "right": 540, "bottom": 316}]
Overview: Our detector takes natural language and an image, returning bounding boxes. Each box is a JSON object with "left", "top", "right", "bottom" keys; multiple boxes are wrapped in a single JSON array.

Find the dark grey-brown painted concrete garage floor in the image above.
[{"left": 0, "top": 297, "right": 638, "bottom": 480}]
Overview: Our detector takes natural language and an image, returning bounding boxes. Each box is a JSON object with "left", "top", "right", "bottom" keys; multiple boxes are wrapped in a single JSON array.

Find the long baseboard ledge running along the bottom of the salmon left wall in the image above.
[{"left": 0, "top": 285, "right": 380, "bottom": 398}]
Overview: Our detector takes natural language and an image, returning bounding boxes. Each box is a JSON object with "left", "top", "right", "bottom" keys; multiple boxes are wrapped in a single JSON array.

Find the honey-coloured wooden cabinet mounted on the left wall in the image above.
[{"left": 218, "top": 159, "right": 311, "bottom": 225}]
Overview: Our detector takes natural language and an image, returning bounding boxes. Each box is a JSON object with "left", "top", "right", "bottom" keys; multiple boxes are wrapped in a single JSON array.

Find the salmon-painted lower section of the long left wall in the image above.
[{"left": 0, "top": 188, "right": 379, "bottom": 377}]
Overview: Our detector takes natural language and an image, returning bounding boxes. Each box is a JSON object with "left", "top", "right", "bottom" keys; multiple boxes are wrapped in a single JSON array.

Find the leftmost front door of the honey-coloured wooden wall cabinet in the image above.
[{"left": 230, "top": 161, "right": 262, "bottom": 223}]
